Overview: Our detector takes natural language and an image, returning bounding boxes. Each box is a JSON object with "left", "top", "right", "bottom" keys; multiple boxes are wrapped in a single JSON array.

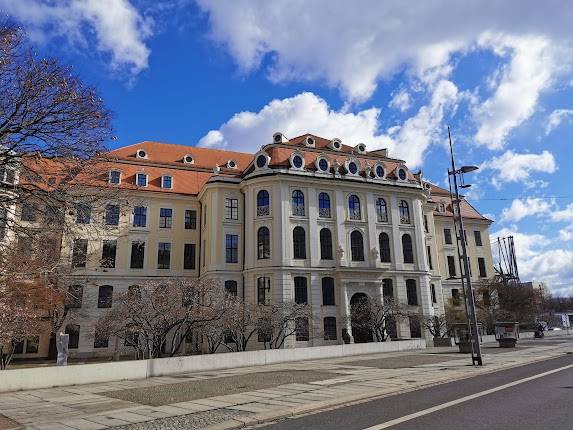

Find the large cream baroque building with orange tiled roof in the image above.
[{"left": 2, "top": 133, "right": 493, "bottom": 357}]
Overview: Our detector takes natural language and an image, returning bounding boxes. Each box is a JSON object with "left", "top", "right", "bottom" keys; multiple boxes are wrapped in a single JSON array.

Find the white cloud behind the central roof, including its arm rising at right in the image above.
[{"left": 199, "top": 85, "right": 458, "bottom": 167}]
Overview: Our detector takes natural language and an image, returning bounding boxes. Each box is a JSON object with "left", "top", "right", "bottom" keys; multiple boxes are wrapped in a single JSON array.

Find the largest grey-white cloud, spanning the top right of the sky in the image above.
[{"left": 198, "top": 0, "right": 571, "bottom": 101}]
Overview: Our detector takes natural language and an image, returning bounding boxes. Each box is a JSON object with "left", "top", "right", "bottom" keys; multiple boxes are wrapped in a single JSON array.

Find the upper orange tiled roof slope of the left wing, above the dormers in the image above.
[{"left": 108, "top": 141, "right": 253, "bottom": 173}]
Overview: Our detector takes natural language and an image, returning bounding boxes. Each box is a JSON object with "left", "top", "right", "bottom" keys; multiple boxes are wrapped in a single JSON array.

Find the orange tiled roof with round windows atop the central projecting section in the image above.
[{"left": 265, "top": 143, "right": 416, "bottom": 181}]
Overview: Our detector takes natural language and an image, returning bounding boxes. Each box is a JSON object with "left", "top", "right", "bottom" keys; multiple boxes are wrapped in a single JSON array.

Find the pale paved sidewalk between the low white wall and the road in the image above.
[{"left": 0, "top": 337, "right": 573, "bottom": 430}]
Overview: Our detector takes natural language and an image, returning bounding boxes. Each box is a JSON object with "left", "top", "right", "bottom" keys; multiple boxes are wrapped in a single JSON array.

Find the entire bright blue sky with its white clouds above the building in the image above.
[{"left": 0, "top": 0, "right": 573, "bottom": 294}]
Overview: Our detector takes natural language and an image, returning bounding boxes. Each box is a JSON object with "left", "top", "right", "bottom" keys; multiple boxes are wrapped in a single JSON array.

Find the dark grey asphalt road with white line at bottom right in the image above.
[{"left": 256, "top": 348, "right": 573, "bottom": 430}]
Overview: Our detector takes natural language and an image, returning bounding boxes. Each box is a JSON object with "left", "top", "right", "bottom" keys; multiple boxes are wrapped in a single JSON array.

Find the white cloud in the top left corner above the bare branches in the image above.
[{"left": 0, "top": 0, "right": 151, "bottom": 73}]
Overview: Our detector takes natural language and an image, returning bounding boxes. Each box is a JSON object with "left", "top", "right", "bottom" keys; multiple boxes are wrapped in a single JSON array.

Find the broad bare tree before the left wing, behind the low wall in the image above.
[{"left": 96, "top": 279, "right": 227, "bottom": 358}]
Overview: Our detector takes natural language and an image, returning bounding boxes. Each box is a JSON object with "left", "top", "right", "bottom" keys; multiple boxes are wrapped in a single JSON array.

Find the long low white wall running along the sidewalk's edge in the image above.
[{"left": 0, "top": 339, "right": 426, "bottom": 392}]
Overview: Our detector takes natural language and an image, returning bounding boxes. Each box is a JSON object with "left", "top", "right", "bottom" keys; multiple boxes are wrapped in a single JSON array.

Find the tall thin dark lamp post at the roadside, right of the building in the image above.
[{"left": 448, "top": 127, "right": 482, "bottom": 366}]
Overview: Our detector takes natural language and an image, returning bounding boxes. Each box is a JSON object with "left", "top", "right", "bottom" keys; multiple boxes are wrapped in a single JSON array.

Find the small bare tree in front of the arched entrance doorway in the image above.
[{"left": 351, "top": 297, "right": 409, "bottom": 342}]
